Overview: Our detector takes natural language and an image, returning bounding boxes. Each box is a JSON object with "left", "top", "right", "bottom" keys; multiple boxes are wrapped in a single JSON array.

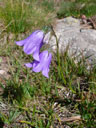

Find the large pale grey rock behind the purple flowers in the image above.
[{"left": 45, "top": 17, "right": 96, "bottom": 61}]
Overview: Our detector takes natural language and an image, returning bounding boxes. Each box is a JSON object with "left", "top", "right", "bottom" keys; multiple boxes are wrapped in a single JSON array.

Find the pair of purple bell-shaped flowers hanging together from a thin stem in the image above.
[{"left": 16, "top": 30, "right": 52, "bottom": 78}]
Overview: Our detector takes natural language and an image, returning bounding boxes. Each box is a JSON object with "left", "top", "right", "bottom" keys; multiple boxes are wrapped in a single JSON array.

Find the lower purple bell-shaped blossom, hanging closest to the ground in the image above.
[{"left": 25, "top": 51, "right": 52, "bottom": 78}]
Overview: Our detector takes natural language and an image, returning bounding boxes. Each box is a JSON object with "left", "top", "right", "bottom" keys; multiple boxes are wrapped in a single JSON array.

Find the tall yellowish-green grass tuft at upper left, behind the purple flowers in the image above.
[{"left": 0, "top": 0, "right": 52, "bottom": 33}]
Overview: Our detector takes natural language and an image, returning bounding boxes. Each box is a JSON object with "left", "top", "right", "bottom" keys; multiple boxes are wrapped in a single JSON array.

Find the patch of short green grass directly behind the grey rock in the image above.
[{"left": 57, "top": 0, "right": 96, "bottom": 18}]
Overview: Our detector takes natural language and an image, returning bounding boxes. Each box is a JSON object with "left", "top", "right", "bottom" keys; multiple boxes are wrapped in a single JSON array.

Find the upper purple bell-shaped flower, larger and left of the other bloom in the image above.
[{"left": 16, "top": 30, "right": 44, "bottom": 61}]
